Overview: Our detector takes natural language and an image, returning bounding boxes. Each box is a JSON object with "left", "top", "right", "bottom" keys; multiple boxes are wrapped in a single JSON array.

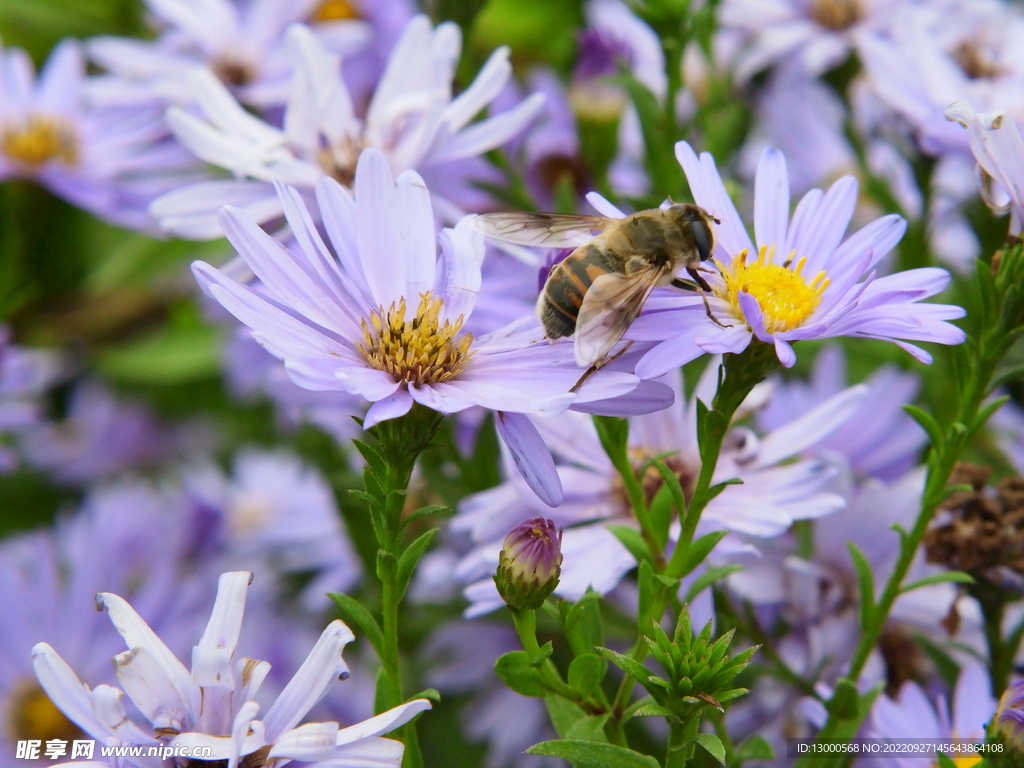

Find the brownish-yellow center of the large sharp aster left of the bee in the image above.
[{"left": 357, "top": 291, "right": 473, "bottom": 385}]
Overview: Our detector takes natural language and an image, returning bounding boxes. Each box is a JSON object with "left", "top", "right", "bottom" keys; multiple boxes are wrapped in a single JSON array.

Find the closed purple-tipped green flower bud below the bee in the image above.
[{"left": 495, "top": 517, "right": 562, "bottom": 610}]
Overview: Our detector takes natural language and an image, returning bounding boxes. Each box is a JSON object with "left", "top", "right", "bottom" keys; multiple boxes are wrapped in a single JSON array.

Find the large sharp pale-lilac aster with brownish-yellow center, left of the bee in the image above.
[{"left": 194, "top": 148, "right": 647, "bottom": 512}]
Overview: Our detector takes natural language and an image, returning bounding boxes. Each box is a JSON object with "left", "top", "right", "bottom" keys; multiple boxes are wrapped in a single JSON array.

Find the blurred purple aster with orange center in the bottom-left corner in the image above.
[{"left": 0, "top": 480, "right": 212, "bottom": 768}]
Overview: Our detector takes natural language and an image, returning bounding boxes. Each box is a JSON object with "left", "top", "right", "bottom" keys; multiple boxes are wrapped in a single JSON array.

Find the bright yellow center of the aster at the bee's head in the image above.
[{"left": 715, "top": 246, "right": 828, "bottom": 333}]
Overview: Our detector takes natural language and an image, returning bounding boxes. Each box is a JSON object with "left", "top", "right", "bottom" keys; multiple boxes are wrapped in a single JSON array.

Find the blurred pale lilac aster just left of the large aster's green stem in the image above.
[{"left": 185, "top": 451, "right": 359, "bottom": 609}]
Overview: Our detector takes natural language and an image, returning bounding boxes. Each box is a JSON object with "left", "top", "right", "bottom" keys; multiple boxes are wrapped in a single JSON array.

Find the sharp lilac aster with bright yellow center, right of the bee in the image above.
[{"left": 626, "top": 141, "right": 965, "bottom": 378}]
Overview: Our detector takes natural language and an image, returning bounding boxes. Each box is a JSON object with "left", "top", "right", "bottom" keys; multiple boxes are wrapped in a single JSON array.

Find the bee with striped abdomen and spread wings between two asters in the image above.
[{"left": 474, "top": 204, "right": 722, "bottom": 374}]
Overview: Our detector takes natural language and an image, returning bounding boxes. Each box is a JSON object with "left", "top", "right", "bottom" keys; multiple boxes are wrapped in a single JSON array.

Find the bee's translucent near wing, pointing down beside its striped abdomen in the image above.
[{"left": 574, "top": 267, "right": 668, "bottom": 368}]
